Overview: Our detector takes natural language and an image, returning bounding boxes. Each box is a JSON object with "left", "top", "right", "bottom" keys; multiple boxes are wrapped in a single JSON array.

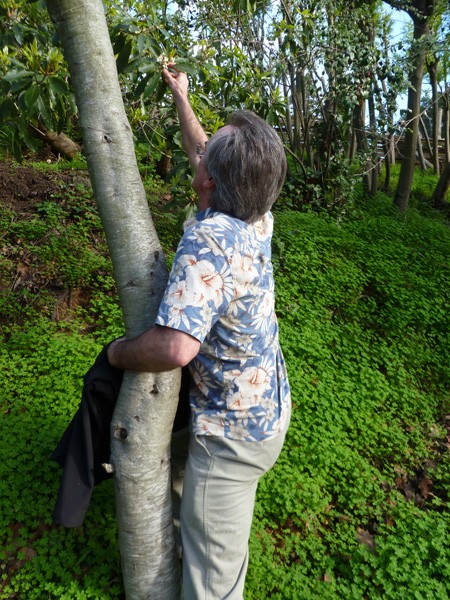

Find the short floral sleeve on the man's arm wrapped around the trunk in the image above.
[{"left": 156, "top": 223, "right": 234, "bottom": 343}]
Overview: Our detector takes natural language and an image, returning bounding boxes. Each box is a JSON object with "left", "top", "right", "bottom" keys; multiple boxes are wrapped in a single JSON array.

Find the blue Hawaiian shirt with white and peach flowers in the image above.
[{"left": 156, "top": 209, "right": 290, "bottom": 441}]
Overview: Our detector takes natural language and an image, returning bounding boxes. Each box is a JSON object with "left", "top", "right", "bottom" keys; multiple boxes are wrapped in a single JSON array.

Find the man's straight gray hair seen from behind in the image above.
[{"left": 204, "top": 110, "right": 286, "bottom": 223}]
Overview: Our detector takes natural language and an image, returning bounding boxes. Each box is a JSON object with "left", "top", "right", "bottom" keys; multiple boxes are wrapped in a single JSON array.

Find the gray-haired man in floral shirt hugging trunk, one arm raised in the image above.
[{"left": 109, "top": 64, "right": 290, "bottom": 600}]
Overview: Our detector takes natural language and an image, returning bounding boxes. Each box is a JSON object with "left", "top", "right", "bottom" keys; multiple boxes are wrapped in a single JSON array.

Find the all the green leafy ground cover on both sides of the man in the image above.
[{"left": 0, "top": 166, "right": 450, "bottom": 600}]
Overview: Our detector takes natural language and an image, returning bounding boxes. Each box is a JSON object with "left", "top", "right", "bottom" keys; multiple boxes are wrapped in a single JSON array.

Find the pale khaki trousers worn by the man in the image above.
[{"left": 181, "top": 425, "right": 287, "bottom": 600}]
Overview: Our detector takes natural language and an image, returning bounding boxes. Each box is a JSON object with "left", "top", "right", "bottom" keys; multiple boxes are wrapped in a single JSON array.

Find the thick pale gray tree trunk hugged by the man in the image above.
[{"left": 44, "top": 0, "right": 179, "bottom": 600}]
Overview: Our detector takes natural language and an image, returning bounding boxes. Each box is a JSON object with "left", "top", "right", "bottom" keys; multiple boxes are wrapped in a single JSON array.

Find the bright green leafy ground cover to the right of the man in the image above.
[{"left": 247, "top": 196, "right": 450, "bottom": 600}]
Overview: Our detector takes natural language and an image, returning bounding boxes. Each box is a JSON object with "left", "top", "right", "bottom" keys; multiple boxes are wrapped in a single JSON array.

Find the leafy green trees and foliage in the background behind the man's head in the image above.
[{"left": 0, "top": 0, "right": 449, "bottom": 211}]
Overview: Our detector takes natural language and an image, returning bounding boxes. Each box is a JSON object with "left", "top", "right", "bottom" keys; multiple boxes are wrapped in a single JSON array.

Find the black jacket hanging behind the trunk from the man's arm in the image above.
[{"left": 51, "top": 346, "right": 190, "bottom": 527}]
